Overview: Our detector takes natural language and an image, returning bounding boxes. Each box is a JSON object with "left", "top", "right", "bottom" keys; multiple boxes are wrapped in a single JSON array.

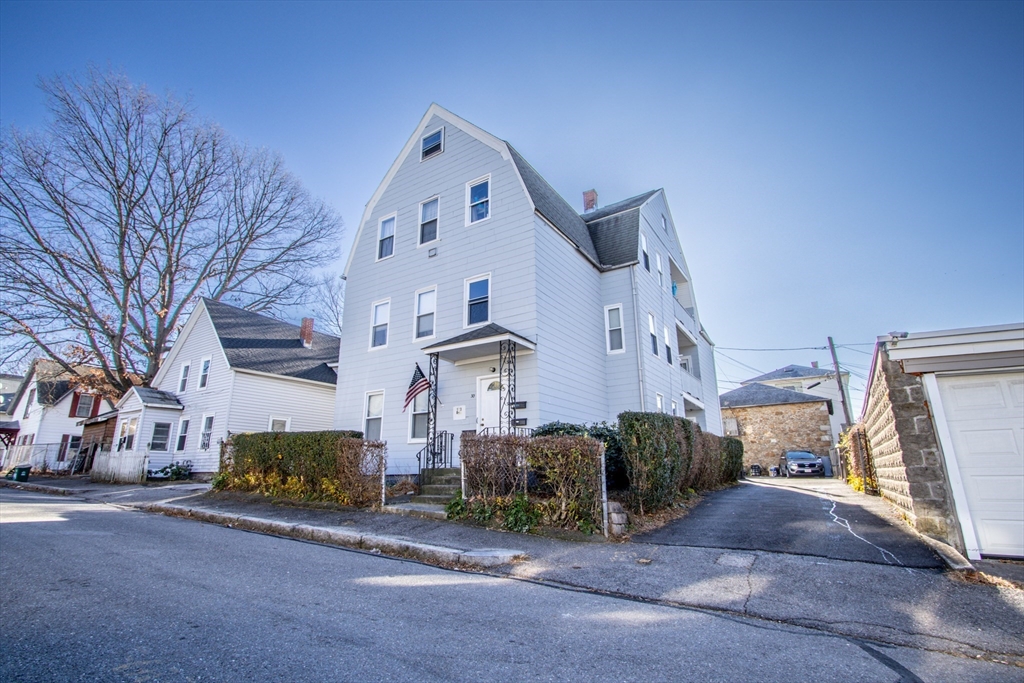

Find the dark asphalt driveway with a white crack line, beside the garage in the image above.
[{"left": 633, "top": 478, "right": 945, "bottom": 569}]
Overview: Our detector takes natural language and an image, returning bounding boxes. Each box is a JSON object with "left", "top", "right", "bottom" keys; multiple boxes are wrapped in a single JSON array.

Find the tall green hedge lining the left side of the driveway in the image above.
[{"left": 618, "top": 412, "right": 743, "bottom": 515}]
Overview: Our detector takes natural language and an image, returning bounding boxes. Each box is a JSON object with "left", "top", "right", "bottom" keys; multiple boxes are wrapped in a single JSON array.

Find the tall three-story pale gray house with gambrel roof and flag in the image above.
[{"left": 335, "top": 104, "right": 722, "bottom": 473}]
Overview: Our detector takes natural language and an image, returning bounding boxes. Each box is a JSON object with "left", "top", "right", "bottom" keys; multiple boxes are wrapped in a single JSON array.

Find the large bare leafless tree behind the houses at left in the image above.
[{"left": 0, "top": 71, "right": 341, "bottom": 393}]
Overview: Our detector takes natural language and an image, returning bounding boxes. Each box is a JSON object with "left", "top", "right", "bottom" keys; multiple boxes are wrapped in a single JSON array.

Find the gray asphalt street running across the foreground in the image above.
[{"left": 0, "top": 489, "right": 1021, "bottom": 681}]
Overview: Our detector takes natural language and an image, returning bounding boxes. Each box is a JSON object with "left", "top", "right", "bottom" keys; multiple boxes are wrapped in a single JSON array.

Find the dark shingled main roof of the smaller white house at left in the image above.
[{"left": 203, "top": 299, "right": 341, "bottom": 384}]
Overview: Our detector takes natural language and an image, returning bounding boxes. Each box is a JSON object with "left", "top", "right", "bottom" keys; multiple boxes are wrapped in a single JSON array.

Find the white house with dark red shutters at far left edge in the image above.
[{"left": 2, "top": 359, "right": 114, "bottom": 469}]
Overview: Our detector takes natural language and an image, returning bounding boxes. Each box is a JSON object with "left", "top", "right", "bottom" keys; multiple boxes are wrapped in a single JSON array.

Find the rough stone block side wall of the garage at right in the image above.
[{"left": 863, "top": 347, "right": 964, "bottom": 551}]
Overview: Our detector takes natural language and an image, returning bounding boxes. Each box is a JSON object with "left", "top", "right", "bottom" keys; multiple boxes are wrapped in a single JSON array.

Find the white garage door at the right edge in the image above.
[{"left": 937, "top": 372, "right": 1024, "bottom": 557}]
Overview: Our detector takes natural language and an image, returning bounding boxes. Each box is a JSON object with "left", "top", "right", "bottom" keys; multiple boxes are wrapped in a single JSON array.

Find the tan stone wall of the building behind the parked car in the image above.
[{"left": 722, "top": 399, "right": 833, "bottom": 473}]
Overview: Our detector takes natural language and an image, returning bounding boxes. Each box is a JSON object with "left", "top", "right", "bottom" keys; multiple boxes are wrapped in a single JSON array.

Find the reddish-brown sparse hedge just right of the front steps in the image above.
[{"left": 449, "top": 434, "right": 602, "bottom": 532}]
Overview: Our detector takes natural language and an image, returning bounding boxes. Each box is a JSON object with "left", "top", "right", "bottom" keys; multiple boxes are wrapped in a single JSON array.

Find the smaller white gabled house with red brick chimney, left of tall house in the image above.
[{"left": 114, "top": 299, "right": 338, "bottom": 473}]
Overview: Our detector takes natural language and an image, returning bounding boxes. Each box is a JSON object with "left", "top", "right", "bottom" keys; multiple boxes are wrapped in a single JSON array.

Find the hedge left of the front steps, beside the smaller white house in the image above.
[{"left": 214, "top": 431, "right": 387, "bottom": 506}]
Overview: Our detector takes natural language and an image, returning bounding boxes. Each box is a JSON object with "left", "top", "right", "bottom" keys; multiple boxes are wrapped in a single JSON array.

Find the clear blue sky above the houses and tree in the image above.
[{"left": 0, "top": 0, "right": 1024, "bottom": 413}]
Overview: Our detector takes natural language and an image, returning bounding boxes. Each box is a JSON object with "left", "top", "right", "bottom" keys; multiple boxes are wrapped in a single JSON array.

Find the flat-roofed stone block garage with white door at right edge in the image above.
[{"left": 861, "top": 324, "right": 1024, "bottom": 559}]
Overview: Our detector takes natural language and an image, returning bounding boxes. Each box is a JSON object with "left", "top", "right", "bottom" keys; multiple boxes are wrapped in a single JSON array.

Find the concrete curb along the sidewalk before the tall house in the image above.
[{"left": 142, "top": 503, "right": 526, "bottom": 568}]
